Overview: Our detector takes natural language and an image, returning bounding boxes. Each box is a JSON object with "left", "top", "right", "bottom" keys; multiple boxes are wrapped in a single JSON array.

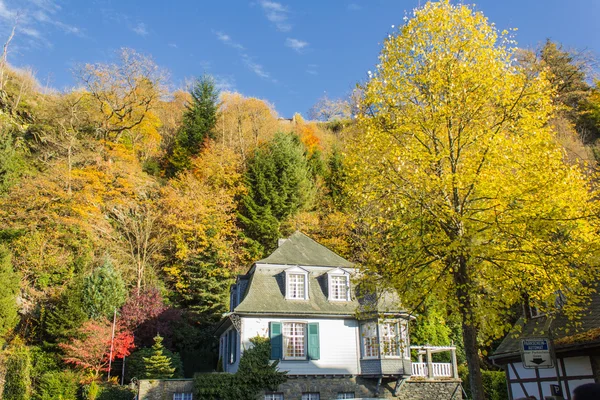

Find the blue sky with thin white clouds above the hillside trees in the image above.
[{"left": 0, "top": 0, "right": 600, "bottom": 117}]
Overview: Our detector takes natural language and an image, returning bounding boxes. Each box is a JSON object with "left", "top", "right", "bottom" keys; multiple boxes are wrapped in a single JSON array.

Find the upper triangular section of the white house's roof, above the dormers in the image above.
[{"left": 256, "top": 231, "right": 353, "bottom": 268}]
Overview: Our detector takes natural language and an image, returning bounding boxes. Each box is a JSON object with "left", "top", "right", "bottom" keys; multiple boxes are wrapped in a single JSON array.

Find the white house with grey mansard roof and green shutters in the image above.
[{"left": 217, "top": 232, "right": 458, "bottom": 400}]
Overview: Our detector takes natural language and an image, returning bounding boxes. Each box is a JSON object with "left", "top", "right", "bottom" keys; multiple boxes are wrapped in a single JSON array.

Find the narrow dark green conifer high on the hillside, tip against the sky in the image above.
[{"left": 166, "top": 75, "right": 219, "bottom": 176}]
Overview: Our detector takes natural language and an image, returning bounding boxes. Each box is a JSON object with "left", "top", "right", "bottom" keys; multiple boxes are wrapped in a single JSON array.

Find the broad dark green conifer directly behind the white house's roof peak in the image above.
[{"left": 238, "top": 133, "right": 315, "bottom": 255}]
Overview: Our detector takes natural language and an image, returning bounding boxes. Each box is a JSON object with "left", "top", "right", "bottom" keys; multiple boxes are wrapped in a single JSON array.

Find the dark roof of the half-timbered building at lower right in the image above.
[{"left": 491, "top": 293, "right": 600, "bottom": 360}]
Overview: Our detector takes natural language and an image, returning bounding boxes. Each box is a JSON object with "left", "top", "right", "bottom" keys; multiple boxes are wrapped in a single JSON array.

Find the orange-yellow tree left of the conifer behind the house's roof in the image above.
[{"left": 159, "top": 141, "right": 252, "bottom": 306}]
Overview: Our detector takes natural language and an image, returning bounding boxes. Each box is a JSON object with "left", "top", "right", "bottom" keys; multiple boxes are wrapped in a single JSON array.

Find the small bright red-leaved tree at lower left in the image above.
[{"left": 59, "top": 319, "right": 134, "bottom": 380}]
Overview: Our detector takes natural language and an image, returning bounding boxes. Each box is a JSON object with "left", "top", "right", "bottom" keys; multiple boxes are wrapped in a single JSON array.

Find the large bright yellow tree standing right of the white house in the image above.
[{"left": 347, "top": 0, "right": 598, "bottom": 400}]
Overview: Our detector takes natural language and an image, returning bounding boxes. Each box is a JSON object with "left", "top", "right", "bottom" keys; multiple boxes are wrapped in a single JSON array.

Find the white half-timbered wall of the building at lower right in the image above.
[{"left": 507, "top": 356, "right": 594, "bottom": 399}]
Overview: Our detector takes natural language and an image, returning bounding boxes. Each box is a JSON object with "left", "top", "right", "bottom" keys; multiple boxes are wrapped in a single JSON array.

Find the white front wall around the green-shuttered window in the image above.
[{"left": 239, "top": 317, "right": 360, "bottom": 375}]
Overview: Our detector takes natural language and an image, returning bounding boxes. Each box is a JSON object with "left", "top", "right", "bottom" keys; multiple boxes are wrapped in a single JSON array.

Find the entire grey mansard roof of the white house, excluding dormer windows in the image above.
[{"left": 234, "top": 232, "right": 404, "bottom": 316}]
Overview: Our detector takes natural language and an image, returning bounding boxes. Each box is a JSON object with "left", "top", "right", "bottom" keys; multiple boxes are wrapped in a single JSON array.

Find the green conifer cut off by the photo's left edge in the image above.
[{"left": 0, "top": 246, "right": 19, "bottom": 347}]
